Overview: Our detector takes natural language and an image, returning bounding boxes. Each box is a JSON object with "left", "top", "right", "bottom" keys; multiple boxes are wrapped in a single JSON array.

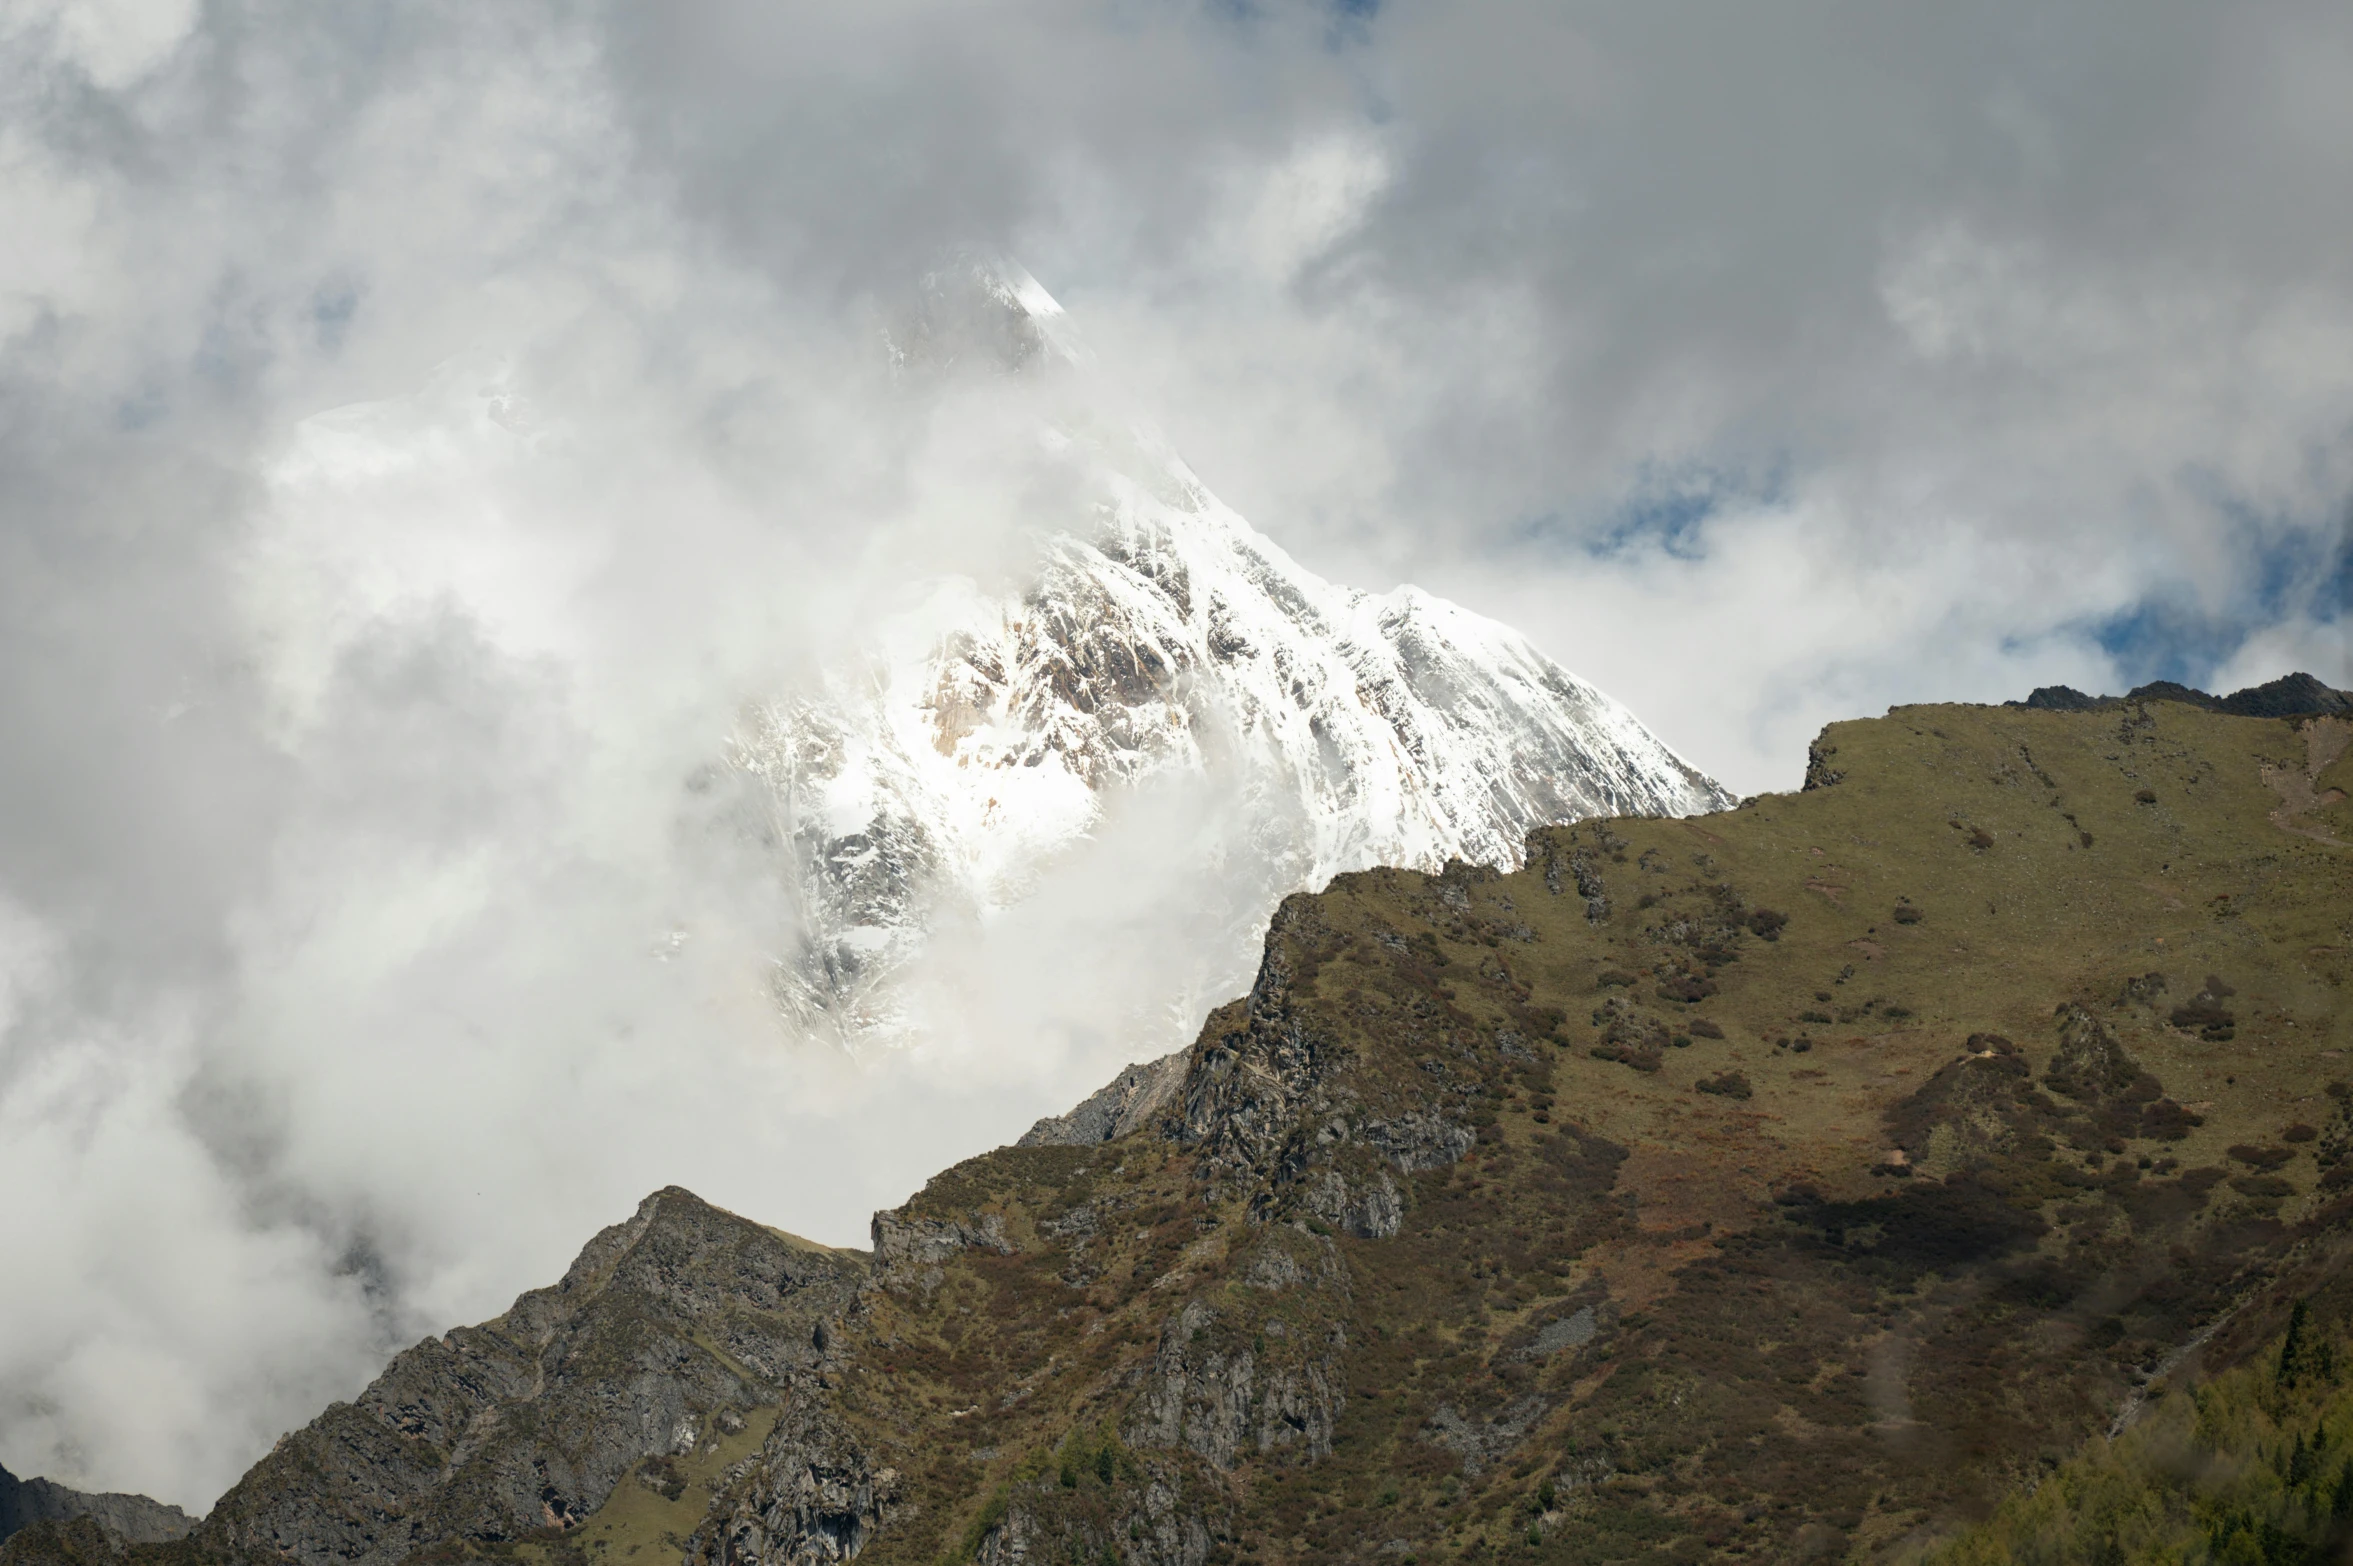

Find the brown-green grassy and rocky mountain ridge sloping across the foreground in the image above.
[{"left": 22, "top": 701, "right": 2353, "bottom": 1566}]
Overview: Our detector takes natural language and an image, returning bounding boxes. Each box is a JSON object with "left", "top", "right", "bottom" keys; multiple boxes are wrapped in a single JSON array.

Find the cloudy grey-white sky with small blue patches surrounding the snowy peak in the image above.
[{"left": 0, "top": 0, "right": 2353, "bottom": 1507}]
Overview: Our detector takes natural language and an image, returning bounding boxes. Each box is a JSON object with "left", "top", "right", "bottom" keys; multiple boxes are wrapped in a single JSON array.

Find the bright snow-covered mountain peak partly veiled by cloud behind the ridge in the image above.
[{"left": 734, "top": 268, "right": 1732, "bottom": 1044}]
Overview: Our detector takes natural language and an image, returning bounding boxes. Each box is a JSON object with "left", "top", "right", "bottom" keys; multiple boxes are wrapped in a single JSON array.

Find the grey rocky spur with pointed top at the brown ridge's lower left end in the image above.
[{"left": 198, "top": 1187, "right": 866, "bottom": 1566}]
